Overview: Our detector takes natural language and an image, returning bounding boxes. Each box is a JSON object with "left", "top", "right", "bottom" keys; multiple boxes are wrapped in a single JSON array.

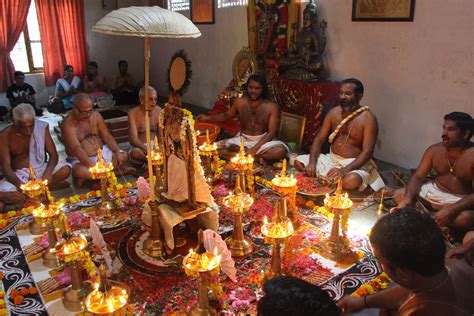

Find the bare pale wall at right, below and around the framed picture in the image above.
[{"left": 319, "top": 0, "right": 474, "bottom": 167}]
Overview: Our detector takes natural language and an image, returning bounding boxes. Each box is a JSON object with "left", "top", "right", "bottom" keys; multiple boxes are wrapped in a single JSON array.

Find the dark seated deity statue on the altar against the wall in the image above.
[{"left": 279, "top": 0, "right": 328, "bottom": 81}]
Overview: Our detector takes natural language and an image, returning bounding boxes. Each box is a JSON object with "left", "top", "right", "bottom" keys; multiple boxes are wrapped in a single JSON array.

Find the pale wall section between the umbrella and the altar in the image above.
[{"left": 150, "top": 7, "right": 248, "bottom": 108}]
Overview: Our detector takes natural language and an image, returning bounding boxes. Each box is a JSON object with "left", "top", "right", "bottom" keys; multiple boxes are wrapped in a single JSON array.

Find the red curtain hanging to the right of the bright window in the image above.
[{"left": 36, "top": 0, "right": 87, "bottom": 86}]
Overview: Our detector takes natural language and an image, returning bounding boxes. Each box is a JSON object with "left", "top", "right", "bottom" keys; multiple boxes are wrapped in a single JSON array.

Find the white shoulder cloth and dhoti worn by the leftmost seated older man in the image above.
[{"left": 0, "top": 120, "right": 71, "bottom": 192}]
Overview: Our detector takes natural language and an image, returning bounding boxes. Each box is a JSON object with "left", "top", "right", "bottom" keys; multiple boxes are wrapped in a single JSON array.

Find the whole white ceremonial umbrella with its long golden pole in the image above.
[{"left": 92, "top": 6, "right": 201, "bottom": 200}]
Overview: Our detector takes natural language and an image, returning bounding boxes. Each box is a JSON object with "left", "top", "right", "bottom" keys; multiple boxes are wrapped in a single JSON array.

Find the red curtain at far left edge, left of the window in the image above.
[{"left": 0, "top": 0, "right": 31, "bottom": 92}]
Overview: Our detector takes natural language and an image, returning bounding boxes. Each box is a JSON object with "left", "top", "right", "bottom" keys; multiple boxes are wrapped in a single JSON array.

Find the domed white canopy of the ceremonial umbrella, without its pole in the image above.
[{"left": 92, "top": 6, "right": 201, "bottom": 38}]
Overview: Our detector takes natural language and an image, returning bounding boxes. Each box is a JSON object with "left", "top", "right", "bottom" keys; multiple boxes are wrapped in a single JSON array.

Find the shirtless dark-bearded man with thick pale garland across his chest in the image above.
[{"left": 295, "top": 78, "right": 384, "bottom": 191}]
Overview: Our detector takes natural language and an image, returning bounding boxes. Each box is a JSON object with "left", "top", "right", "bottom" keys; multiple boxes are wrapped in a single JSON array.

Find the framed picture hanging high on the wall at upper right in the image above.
[{"left": 352, "top": 0, "right": 415, "bottom": 21}]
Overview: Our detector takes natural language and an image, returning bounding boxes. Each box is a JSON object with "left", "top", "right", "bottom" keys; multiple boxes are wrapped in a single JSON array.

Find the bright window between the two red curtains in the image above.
[{"left": 10, "top": 0, "right": 43, "bottom": 72}]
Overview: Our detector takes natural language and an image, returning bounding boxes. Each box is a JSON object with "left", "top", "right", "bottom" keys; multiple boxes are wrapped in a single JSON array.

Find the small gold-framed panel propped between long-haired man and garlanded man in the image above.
[{"left": 278, "top": 112, "right": 306, "bottom": 150}]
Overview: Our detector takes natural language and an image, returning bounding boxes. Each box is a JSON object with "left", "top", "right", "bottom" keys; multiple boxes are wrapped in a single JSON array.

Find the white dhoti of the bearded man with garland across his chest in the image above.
[{"left": 296, "top": 152, "right": 385, "bottom": 191}]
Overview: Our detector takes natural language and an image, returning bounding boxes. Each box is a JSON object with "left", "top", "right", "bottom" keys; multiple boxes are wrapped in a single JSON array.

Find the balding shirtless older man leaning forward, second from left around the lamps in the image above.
[{"left": 61, "top": 93, "right": 134, "bottom": 186}]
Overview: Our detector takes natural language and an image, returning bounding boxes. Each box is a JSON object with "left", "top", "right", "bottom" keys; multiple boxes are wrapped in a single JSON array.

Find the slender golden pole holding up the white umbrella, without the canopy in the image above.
[{"left": 144, "top": 36, "right": 156, "bottom": 201}]
